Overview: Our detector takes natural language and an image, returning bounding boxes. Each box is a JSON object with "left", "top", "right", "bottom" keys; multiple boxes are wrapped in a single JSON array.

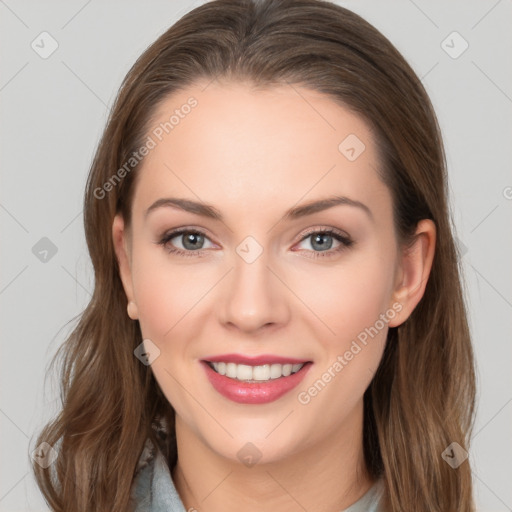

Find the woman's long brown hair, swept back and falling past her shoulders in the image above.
[{"left": 33, "top": 0, "right": 475, "bottom": 512}]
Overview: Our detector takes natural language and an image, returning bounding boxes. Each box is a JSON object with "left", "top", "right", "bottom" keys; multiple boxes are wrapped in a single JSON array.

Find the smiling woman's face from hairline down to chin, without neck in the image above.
[{"left": 114, "top": 83, "right": 412, "bottom": 462}]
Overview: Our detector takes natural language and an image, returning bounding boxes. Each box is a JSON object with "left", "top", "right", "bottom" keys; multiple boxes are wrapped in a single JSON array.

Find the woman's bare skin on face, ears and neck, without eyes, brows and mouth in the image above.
[{"left": 112, "top": 82, "right": 435, "bottom": 512}]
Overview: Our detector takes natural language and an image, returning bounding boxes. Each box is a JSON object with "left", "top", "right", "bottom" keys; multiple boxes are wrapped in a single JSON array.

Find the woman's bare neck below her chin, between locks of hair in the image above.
[{"left": 172, "top": 403, "right": 374, "bottom": 512}]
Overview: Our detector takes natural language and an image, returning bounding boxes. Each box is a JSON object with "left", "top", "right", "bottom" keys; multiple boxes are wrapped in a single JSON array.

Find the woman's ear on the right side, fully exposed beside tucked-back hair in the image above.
[{"left": 388, "top": 219, "right": 436, "bottom": 327}]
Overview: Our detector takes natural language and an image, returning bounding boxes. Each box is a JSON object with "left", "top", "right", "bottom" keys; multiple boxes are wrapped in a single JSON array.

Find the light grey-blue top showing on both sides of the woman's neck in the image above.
[{"left": 131, "top": 416, "right": 384, "bottom": 512}]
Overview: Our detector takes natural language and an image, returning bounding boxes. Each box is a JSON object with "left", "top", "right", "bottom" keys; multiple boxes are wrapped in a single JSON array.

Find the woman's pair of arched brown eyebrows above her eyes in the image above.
[{"left": 144, "top": 196, "right": 374, "bottom": 222}]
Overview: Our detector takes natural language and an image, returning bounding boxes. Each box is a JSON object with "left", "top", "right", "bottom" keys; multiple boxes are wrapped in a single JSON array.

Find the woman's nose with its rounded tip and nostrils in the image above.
[{"left": 219, "top": 251, "right": 293, "bottom": 334}]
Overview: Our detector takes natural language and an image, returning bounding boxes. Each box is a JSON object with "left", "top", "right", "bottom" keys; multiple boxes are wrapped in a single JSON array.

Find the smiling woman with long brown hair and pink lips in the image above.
[{"left": 34, "top": 0, "right": 475, "bottom": 512}]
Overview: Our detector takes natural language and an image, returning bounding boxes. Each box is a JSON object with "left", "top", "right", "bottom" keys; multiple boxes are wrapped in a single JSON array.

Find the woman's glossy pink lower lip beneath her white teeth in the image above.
[{"left": 201, "top": 361, "right": 312, "bottom": 404}]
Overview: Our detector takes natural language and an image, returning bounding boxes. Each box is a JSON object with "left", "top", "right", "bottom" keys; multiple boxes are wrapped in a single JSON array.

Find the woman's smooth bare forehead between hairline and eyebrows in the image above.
[{"left": 133, "top": 82, "right": 387, "bottom": 222}]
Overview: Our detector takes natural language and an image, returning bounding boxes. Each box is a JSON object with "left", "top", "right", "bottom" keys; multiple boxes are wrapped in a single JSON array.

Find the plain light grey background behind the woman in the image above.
[{"left": 0, "top": 0, "right": 512, "bottom": 512}]
